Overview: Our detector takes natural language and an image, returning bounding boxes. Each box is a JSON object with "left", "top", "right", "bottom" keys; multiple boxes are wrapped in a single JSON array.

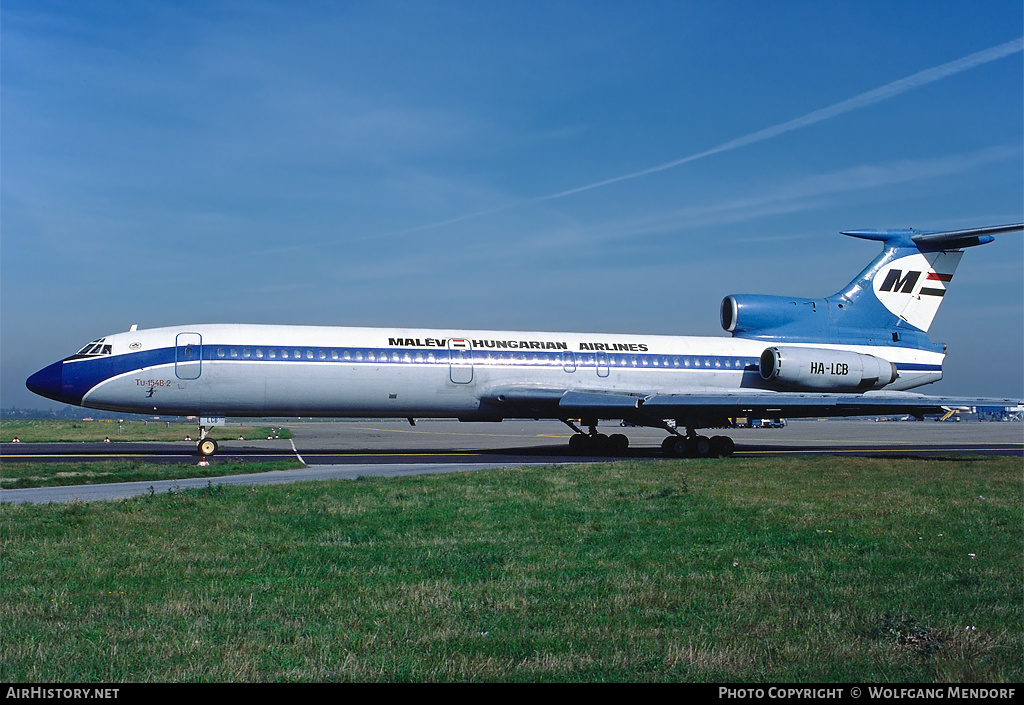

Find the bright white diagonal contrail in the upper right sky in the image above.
[{"left": 534, "top": 37, "right": 1024, "bottom": 201}]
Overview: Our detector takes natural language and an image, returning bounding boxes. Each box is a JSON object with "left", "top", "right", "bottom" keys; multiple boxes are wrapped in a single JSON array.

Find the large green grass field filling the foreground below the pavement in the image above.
[{"left": 0, "top": 457, "right": 1024, "bottom": 682}]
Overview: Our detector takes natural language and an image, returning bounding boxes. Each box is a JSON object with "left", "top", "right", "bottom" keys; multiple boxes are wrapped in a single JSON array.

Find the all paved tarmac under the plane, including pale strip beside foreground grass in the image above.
[{"left": 0, "top": 420, "right": 1024, "bottom": 503}]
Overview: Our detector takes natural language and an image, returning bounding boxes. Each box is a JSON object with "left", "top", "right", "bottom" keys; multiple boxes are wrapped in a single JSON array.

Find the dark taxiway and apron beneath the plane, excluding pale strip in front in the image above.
[{"left": 0, "top": 419, "right": 1024, "bottom": 465}]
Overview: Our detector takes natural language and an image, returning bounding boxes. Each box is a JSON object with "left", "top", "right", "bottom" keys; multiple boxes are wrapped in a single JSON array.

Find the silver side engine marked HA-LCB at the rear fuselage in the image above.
[{"left": 759, "top": 346, "right": 899, "bottom": 391}]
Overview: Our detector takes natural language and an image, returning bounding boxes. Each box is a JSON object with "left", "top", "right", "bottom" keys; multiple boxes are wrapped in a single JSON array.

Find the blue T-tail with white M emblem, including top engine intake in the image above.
[{"left": 722, "top": 223, "right": 1024, "bottom": 351}]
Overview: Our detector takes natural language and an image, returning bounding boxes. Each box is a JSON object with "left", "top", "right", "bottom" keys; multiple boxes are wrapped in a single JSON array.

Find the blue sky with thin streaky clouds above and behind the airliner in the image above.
[{"left": 0, "top": 0, "right": 1024, "bottom": 408}]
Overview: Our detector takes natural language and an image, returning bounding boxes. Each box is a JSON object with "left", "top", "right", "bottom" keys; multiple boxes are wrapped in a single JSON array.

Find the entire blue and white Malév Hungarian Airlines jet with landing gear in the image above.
[{"left": 26, "top": 223, "right": 1024, "bottom": 457}]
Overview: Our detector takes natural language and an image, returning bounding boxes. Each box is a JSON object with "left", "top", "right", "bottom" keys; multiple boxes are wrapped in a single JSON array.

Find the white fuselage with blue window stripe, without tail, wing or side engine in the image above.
[{"left": 63, "top": 325, "right": 943, "bottom": 419}]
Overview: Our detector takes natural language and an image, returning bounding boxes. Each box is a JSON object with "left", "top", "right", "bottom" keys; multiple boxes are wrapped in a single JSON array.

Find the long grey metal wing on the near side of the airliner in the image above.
[{"left": 482, "top": 386, "right": 1020, "bottom": 427}]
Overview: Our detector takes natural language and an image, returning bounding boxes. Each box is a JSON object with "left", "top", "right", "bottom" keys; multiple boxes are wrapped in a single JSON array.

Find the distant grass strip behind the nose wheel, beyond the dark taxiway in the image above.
[{"left": 0, "top": 419, "right": 292, "bottom": 443}]
